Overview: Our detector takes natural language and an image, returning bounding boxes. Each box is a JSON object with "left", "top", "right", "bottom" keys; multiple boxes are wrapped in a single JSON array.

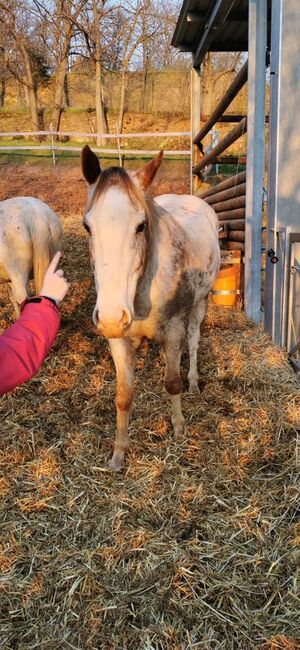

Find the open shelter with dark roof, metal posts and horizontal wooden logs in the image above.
[{"left": 172, "top": 0, "right": 300, "bottom": 366}]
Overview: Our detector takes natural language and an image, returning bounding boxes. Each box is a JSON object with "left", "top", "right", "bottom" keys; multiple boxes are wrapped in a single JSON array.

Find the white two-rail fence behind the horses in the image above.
[{"left": 0, "top": 127, "right": 191, "bottom": 165}]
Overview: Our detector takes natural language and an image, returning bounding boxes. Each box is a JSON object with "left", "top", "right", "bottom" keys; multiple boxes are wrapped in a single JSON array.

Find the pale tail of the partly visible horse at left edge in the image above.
[{"left": 30, "top": 206, "right": 61, "bottom": 294}]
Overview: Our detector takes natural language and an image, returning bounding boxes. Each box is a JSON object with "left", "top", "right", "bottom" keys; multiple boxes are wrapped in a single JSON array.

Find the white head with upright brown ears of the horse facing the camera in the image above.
[{"left": 82, "top": 146, "right": 163, "bottom": 338}]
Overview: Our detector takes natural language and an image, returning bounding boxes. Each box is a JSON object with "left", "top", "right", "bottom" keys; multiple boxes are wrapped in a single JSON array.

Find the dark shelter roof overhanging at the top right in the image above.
[{"left": 172, "top": 0, "right": 272, "bottom": 67}]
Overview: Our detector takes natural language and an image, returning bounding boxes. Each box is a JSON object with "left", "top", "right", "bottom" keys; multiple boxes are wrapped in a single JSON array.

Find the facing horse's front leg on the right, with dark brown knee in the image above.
[{"left": 164, "top": 318, "right": 185, "bottom": 435}]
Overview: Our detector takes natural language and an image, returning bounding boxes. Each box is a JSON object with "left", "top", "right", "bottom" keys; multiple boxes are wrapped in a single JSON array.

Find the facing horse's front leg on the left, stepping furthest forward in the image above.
[{"left": 108, "top": 339, "right": 135, "bottom": 470}]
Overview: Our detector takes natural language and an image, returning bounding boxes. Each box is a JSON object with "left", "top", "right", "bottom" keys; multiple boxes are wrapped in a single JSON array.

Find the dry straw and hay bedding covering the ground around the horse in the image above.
[{"left": 0, "top": 166, "right": 300, "bottom": 650}]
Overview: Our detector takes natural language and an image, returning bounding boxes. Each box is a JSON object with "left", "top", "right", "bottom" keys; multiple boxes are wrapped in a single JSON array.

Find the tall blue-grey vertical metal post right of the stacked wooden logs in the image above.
[{"left": 245, "top": 0, "right": 267, "bottom": 323}]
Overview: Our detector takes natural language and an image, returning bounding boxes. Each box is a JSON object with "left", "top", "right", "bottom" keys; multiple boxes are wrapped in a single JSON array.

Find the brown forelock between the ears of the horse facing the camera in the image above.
[{"left": 88, "top": 167, "right": 156, "bottom": 232}]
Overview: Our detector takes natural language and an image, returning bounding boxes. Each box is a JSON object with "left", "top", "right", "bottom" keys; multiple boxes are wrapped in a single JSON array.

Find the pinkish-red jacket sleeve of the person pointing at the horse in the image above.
[{"left": 0, "top": 297, "right": 60, "bottom": 395}]
